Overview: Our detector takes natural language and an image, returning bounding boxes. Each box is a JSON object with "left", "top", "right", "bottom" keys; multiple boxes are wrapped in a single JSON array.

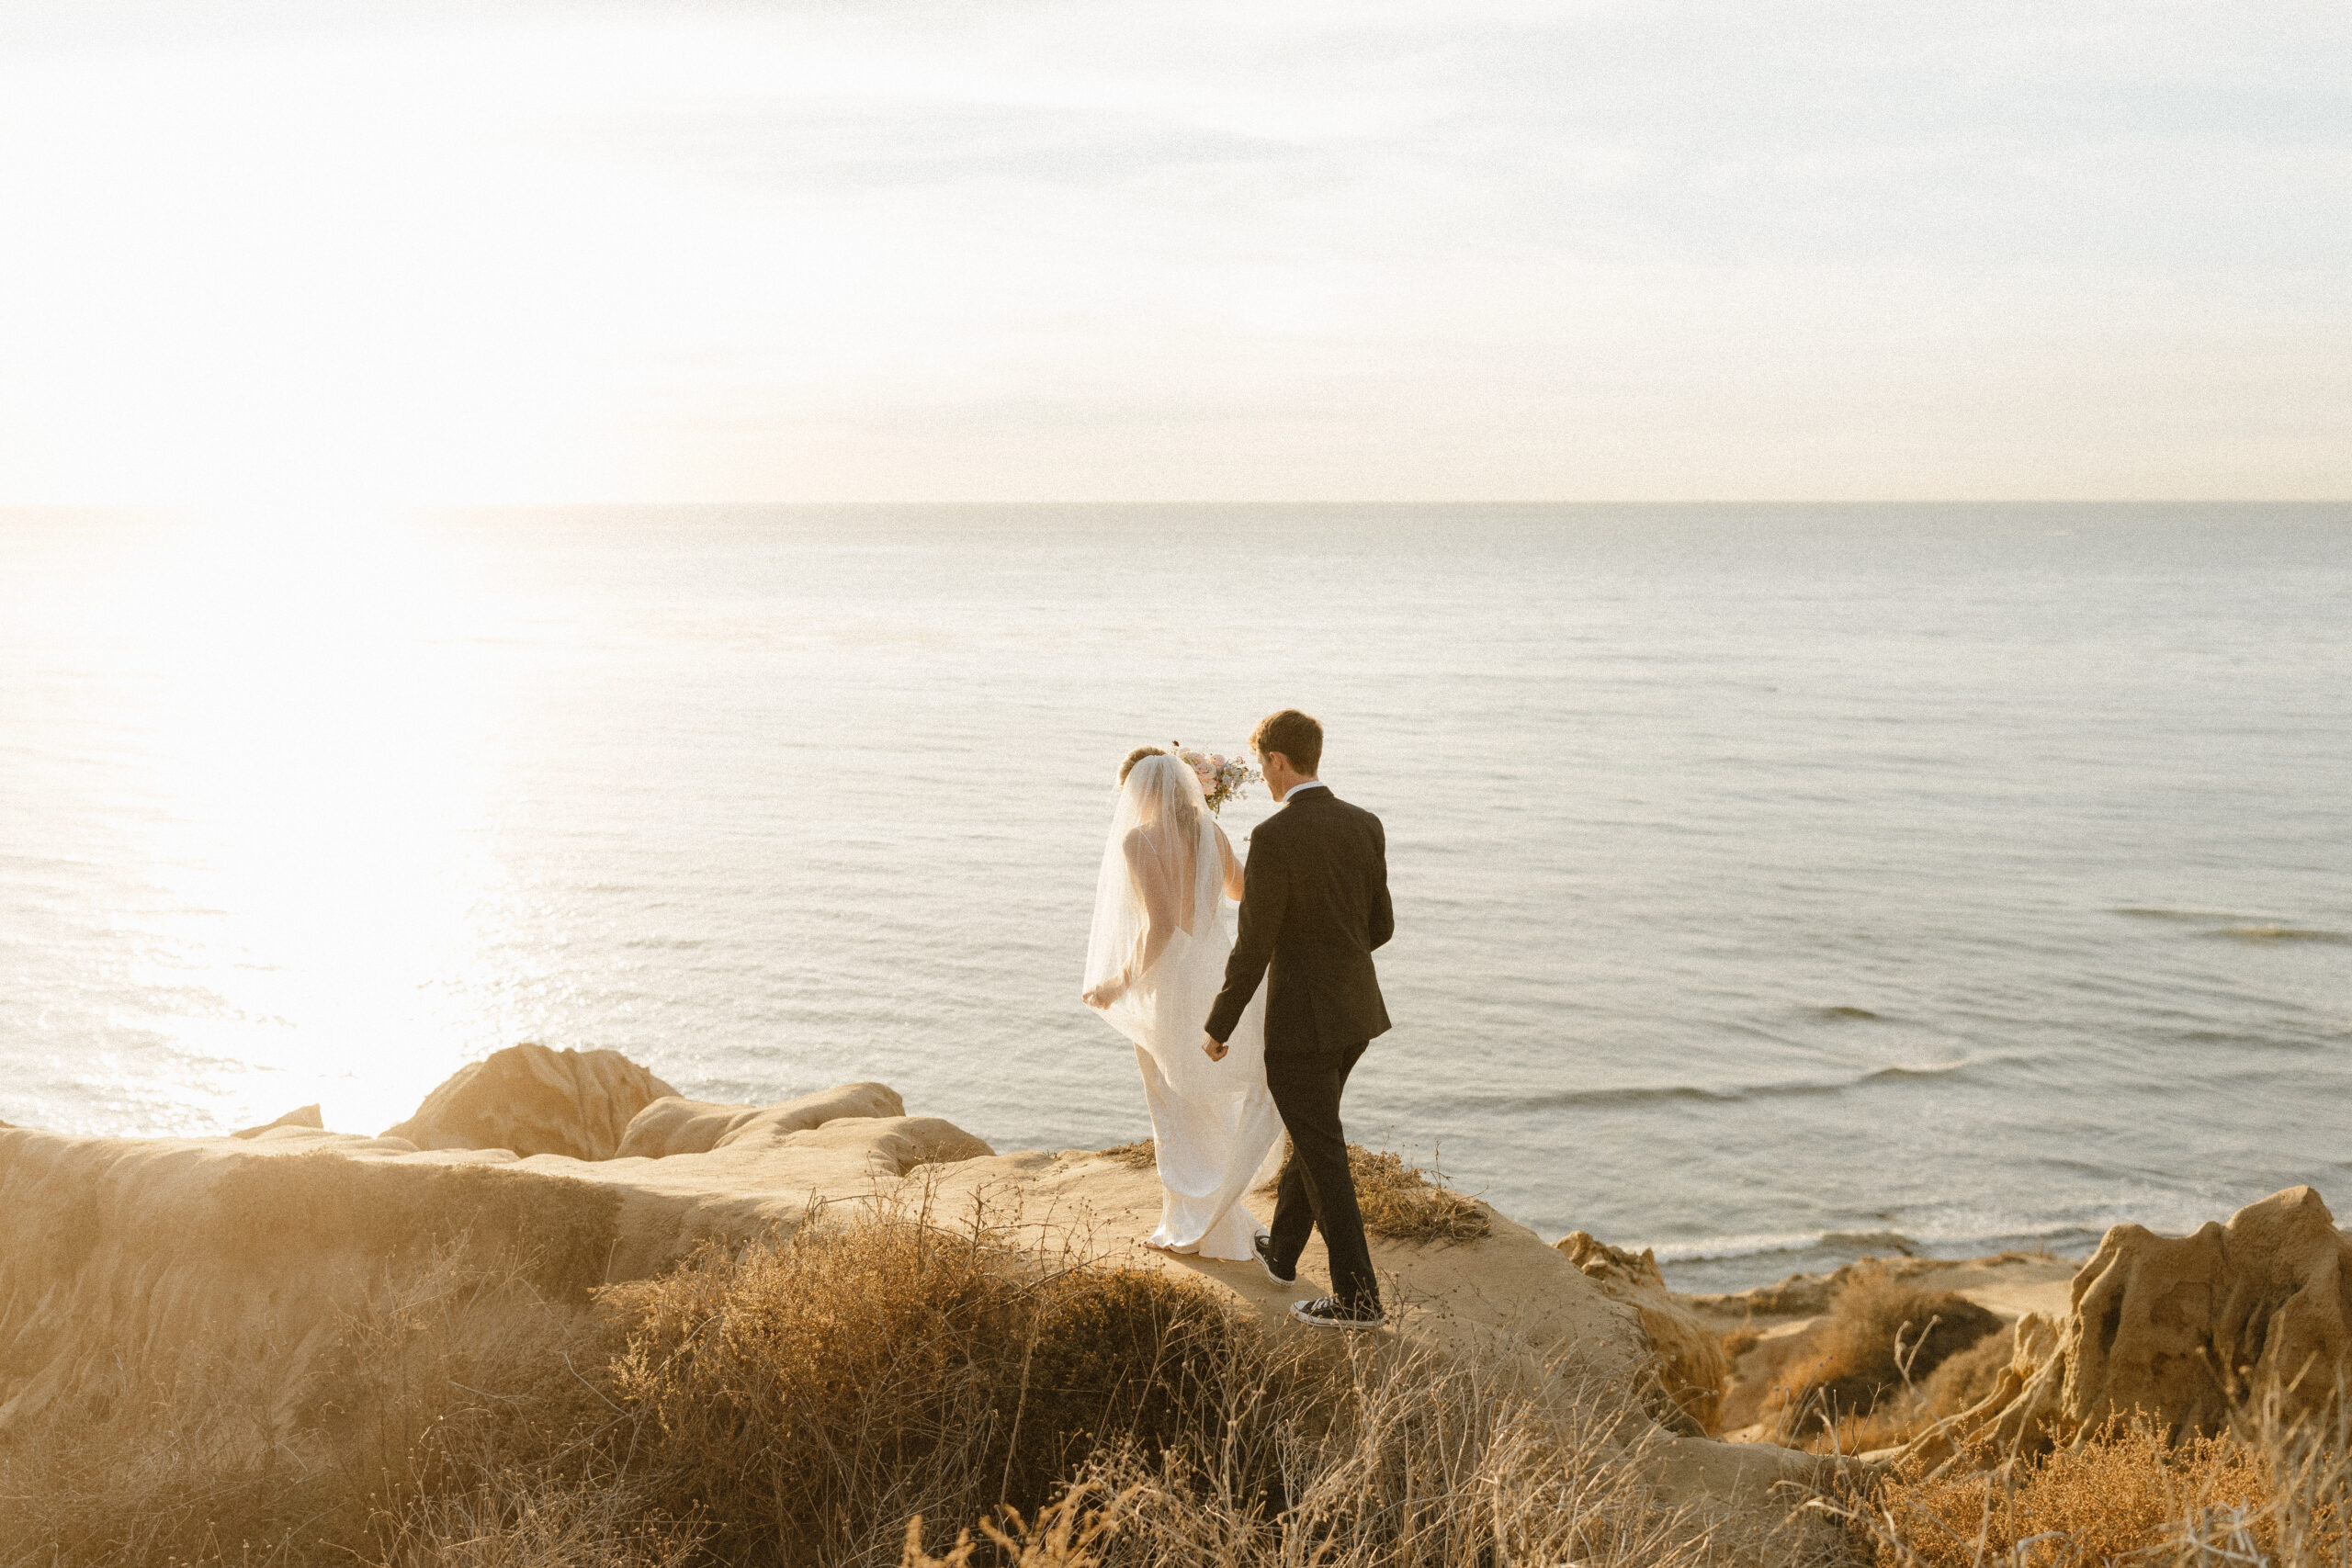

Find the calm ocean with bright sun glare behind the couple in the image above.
[{"left": 0, "top": 505, "right": 2352, "bottom": 1288}]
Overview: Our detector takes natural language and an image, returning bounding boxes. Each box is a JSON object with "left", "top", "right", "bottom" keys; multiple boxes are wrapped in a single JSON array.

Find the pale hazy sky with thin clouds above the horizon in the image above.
[{"left": 0, "top": 0, "right": 2352, "bottom": 505}]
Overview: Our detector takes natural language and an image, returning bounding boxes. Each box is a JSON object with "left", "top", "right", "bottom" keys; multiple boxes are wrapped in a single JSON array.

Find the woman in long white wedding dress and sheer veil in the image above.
[{"left": 1084, "top": 748, "right": 1282, "bottom": 1262}]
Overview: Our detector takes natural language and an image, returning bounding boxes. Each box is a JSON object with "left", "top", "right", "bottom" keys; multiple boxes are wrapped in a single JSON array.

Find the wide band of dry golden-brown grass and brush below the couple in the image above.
[{"left": 0, "top": 1190, "right": 1799, "bottom": 1568}]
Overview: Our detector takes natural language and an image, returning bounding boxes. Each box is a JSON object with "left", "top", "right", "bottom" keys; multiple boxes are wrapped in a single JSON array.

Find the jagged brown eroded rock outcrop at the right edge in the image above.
[{"left": 1912, "top": 1187, "right": 2352, "bottom": 1458}]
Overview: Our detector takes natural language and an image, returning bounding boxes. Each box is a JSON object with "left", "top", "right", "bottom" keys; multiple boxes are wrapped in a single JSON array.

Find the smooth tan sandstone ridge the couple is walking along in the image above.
[{"left": 0, "top": 1048, "right": 1853, "bottom": 1538}]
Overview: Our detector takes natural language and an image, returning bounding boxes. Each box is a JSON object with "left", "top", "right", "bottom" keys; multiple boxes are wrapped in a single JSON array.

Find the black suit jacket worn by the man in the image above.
[{"left": 1209, "top": 787, "right": 1397, "bottom": 1055}]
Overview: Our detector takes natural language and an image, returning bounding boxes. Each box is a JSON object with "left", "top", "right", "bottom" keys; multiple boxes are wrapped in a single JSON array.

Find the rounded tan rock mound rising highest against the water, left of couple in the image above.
[{"left": 383, "top": 1043, "right": 677, "bottom": 1159}]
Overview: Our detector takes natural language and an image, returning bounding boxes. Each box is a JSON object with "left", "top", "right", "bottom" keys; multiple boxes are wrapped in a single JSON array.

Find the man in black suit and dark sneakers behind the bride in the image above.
[{"left": 1200, "top": 707, "right": 1397, "bottom": 1328}]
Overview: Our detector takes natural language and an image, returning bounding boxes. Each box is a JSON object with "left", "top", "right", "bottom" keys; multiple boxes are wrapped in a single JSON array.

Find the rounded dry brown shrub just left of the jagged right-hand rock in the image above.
[{"left": 1773, "top": 1272, "right": 2002, "bottom": 1453}]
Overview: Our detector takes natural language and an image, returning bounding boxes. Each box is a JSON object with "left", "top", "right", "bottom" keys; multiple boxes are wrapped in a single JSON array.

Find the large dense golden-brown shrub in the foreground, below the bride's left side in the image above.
[{"left": 606, "top": 1208, "right": 1239, "bottom": 1559}]
